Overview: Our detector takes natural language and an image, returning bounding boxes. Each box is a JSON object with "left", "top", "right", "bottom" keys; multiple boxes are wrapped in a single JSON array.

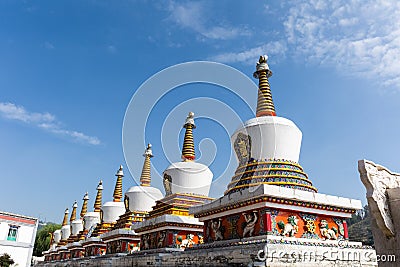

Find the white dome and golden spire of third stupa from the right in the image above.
[{"left": 125, "top": 144, "right": 163, "bottom": 212}]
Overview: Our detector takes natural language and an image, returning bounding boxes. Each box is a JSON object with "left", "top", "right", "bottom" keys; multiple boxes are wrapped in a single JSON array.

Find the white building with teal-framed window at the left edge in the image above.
[{"left": 0, "top": 211, "right": 39, "bottom": 267}]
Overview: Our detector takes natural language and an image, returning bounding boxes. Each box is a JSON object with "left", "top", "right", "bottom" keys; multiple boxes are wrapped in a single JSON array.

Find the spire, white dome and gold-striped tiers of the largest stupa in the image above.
[{"left": 225, "top": 56, "right": 317, "bottom": 194}]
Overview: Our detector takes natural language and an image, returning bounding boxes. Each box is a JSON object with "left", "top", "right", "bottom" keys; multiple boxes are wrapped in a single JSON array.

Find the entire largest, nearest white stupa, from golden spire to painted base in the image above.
[{"left": 190, "top": 56, "right": 372, "bottom": 266}]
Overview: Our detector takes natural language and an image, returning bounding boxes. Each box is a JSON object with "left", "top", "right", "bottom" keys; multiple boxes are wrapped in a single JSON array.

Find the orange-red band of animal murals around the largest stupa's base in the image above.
[{"left": 204, "top": 208, "right": 347, "bottom": 243}]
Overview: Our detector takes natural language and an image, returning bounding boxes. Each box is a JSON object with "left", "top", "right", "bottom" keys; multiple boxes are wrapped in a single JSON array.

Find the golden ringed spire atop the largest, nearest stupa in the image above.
[{"left": 253, "top": 55, "right": 276, "bottom": 117}]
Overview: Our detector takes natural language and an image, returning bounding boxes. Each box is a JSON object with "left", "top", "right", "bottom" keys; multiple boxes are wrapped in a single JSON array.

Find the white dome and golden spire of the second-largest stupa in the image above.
[{"left": 163, "top": 112, "right": 213, "bottom": 196}]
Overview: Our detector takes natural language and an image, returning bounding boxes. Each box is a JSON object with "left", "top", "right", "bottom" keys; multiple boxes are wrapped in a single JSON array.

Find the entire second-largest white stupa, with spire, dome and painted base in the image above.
[{"left": 132, "top": 112, "right": 213, "bottom": 250}]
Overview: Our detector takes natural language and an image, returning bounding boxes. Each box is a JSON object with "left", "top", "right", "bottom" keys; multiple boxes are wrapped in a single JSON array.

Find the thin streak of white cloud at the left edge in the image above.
[{"left": 0, "top": 102, "right": 100, "bottom": 145}]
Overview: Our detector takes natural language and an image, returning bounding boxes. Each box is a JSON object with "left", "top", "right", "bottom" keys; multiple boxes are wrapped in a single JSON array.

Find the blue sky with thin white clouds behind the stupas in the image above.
[{"left": 0, "top": 0, "right": 400, "bottom": 222}]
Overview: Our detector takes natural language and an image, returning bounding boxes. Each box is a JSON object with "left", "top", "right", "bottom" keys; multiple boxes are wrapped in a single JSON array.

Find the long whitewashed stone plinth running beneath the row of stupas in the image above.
[{"left": 38, "top": 235, "right": 378, "bottom": 267}]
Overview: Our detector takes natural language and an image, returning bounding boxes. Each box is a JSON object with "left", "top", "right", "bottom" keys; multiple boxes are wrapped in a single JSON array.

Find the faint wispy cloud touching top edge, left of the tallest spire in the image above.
[{"left": 168, "top": 1, "right": 251, "bottom": 40}]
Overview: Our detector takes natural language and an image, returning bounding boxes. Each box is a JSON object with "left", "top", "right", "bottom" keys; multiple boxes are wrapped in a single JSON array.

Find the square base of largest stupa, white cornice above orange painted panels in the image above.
[{"left": 190, "top": 184, "right": 361, "bottom": 243}]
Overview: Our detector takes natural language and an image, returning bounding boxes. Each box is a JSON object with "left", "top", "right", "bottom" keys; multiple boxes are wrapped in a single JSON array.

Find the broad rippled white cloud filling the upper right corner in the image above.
[{"left": 213, "top": 0, "right": 400, "bottom": 89}]
